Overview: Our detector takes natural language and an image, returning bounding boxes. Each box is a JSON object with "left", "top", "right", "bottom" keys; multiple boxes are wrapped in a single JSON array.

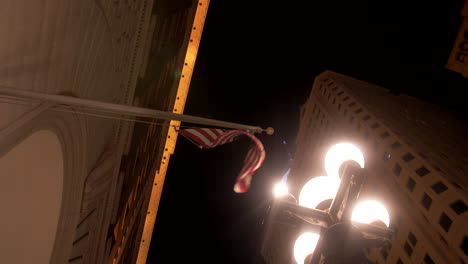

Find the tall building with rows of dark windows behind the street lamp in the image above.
[{"left": 262, "top": 71, "right": 468, "bottom": 264}]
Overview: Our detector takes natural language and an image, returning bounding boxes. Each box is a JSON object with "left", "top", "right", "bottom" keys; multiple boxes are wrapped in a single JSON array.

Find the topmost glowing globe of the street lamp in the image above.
[{"left": 325, "top": 143, "right": 364, "bottom": 177}]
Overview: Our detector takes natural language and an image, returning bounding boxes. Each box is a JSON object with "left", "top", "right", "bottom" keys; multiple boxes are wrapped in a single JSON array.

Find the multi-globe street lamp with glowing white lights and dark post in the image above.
[{"left": 275, "top": 143, "right": 392, "bottom": 264}]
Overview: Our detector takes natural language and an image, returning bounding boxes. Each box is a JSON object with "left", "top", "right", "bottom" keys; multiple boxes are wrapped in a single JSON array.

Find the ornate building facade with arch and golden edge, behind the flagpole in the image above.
[{"left": 0, "top": 0, "right": 209, "bottom": 264}]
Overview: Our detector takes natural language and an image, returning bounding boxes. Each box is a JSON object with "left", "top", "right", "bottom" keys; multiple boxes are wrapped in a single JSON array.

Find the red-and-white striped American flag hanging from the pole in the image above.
[{"left": 179, "top": 128, "right": 265, "bottom": 193}]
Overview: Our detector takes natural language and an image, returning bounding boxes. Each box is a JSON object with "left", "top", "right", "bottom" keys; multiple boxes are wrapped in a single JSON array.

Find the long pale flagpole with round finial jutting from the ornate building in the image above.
[{"left": 0, "top": 86, "right": 274, "bottom": 135}]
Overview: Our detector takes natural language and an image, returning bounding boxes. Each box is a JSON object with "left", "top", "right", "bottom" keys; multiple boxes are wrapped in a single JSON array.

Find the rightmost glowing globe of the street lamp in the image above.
[{"left": 351, "top": 200, "right": 390, "bottom": 227}]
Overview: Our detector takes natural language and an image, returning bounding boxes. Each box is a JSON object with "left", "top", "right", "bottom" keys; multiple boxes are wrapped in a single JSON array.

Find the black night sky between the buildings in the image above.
[{"left": 148, "top": 0, "right": 468, "bottom": 263}]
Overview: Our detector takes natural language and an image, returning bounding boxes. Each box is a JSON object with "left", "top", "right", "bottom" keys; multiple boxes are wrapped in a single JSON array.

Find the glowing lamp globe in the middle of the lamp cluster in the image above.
[{"left": 299, "top": 176, "right": 340, "bottom": 208}]
